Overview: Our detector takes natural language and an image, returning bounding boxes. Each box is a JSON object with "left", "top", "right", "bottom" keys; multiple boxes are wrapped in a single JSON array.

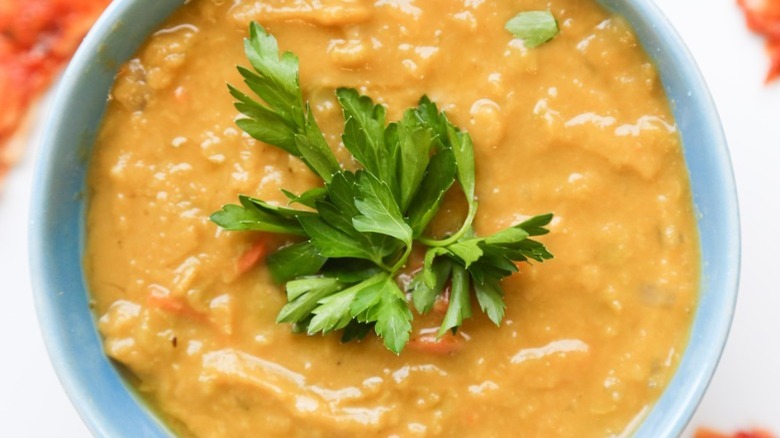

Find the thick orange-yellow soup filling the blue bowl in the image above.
[{"left": 85, "top": 0, "right": 699, "bottom": 437}]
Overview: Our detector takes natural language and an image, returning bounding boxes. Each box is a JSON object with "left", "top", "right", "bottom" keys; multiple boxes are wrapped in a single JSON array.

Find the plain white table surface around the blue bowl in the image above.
[{"left": 0, "top": 0, "right": 780, "bottom": 437}]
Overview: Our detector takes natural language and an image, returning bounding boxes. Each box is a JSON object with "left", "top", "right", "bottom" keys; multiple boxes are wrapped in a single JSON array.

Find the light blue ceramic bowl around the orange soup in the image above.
[{"left": 30, "top": 0, "right": 740, "bottom": 438}]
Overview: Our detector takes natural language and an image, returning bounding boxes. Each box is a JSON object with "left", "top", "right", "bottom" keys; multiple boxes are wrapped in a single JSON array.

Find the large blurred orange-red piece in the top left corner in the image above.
[{"left": 0, "top": 0, "right": 110, "bottom": 180}]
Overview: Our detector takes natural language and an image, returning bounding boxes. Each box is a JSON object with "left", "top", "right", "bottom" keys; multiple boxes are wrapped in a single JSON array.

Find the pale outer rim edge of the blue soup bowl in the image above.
[{"left": 29, "top": 0, "right": 741, "bottom": 437}]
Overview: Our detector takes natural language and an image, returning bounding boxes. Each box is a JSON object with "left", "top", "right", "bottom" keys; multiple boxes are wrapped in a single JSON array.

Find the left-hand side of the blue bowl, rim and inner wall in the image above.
[{"left": 28, "top": 0, "right": 190, "bottom": 437}]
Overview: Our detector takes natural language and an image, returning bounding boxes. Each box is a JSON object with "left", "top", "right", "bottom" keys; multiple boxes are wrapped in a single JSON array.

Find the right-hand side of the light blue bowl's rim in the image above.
[{"left": 600, "top": 0, "right": 742, "bottom": 438}]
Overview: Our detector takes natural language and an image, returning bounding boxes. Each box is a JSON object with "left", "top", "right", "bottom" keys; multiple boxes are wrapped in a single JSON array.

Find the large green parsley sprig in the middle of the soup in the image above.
[{"left": 211, "top": 23, "right": 552, "bottom": 354}]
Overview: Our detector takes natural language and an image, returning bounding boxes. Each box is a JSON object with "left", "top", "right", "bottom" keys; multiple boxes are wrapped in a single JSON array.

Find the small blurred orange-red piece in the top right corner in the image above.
[{"left": 737, "top": 0, "right": 780, "bottom": 82}]
